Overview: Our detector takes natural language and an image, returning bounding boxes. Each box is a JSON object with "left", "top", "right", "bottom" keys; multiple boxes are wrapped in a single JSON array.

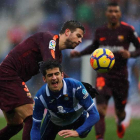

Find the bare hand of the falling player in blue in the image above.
[{"left": 58, "top": 130, "right": 79, "bottom": 138}]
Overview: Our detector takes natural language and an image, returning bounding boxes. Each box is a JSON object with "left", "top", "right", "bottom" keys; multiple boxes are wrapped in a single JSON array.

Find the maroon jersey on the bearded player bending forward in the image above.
[{"left": 0, "top": 32, "right": 62, "bottom": 82}]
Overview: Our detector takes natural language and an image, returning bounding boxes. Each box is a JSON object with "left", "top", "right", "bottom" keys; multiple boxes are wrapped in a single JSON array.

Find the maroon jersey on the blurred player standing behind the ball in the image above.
[{"left": 81, "top": 22, "right": 140, "bottom": 79}]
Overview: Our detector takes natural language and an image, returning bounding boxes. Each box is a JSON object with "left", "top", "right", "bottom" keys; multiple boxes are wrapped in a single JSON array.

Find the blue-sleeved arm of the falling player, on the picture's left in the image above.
[{"left": 30, "top": 96, "right": 45, "bottom": 140}]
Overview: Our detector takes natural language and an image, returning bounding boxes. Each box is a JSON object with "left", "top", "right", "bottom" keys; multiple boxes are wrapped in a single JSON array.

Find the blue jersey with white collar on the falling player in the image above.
[{"left": 33, "top": 78, "right": 95, "bottom": 126}]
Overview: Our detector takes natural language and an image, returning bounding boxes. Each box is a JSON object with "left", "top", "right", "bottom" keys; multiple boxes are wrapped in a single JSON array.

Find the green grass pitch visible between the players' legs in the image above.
[{"left": 0, "top": 118, "right": 140, "bottom": 140}]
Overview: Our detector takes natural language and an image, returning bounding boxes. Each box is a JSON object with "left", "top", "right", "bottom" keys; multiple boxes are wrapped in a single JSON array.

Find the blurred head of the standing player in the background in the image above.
[{"left": 106, "top": 2, "right": 121, "bottom": 26}]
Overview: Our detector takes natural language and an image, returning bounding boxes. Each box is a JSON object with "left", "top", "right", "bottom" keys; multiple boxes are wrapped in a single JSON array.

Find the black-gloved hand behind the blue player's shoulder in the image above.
[{"left": 82, "top": 82, "right": 99, "bottom": 98}]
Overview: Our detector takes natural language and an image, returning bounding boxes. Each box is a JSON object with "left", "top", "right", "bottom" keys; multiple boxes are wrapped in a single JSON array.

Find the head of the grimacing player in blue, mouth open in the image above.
[{"left": 40, "top": 60, "right": 64, "bottom": 92}]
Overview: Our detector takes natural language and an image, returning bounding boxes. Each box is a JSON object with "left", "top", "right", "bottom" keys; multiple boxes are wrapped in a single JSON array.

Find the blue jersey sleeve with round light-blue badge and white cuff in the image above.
[{"left": 75, "top": 82, "right": 95, "bottom": 111}]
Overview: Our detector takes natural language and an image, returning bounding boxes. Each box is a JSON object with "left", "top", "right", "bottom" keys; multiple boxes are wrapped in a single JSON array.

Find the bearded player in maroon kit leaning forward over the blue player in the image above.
[{"left": 0, "top": 21, "right": 85, "bottom": 140}]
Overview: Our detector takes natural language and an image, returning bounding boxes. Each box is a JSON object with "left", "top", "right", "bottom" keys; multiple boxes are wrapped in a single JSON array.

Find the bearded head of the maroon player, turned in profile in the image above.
[{"left": 60, "top": 20, "right": 85, "bottom": 49}]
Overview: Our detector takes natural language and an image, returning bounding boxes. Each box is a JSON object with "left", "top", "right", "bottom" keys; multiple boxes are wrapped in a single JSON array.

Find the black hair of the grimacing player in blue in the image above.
[{"left": 39, "top": 60, "right": 62, "bottom": 76}]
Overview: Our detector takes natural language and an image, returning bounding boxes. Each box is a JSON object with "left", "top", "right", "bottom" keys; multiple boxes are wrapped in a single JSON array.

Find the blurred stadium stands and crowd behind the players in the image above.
[{"left": 0, "top": 0, "right": 140, "bottom": 140}]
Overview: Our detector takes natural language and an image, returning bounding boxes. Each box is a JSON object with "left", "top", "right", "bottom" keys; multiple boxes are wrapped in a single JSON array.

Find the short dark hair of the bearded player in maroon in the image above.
[{"left": 60, "top": 20, "right": 85, "bottom": 34}]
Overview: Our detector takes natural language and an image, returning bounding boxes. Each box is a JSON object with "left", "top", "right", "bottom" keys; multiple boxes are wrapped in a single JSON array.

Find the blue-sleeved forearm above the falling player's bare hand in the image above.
[{"left": 76, "top": 107, "right": 100, "bottom": 135}]
